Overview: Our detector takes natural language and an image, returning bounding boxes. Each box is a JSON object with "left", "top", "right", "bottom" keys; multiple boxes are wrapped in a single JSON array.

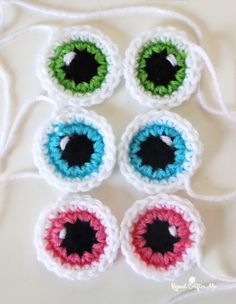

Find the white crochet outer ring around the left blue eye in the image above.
[{"left": 33, "top": 107, "right": 116, "bottom": 192}]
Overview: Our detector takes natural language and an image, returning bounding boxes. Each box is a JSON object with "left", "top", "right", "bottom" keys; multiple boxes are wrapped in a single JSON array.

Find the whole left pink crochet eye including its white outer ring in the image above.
[{"left": 34, "top": 195, "right": 119, "bottom": 280}]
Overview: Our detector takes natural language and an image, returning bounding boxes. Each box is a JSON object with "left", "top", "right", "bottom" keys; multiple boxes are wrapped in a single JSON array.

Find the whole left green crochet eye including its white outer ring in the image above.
[{"left": 39, "top": 26, "right": 121, "bottom": 106}]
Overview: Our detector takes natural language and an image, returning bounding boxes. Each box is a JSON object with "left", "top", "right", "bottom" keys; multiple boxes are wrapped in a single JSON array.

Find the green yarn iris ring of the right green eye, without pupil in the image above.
[{"left": 137, "top": 40, "right": 187, "bottom": 97}]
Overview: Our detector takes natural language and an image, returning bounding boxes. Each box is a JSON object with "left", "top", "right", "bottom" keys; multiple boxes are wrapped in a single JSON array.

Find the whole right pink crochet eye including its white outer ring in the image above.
[{"left": 121, "top": 194, "right": 204, "bottom": 281}]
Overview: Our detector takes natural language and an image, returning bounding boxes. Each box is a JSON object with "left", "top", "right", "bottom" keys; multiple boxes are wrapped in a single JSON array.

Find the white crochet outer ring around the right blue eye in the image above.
[{"left": 118, "top": 110, "right": 203, "bottom": 194}]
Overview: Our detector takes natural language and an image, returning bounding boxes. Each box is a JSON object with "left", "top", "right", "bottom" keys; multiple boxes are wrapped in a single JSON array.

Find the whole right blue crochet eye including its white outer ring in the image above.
[{"left": 119, "top": 111, "right": 202, "bottom": 193}]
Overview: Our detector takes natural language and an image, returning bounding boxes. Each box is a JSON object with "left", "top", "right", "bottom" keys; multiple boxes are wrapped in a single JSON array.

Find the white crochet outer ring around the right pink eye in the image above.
[{"left": 120, "top": 194, "right": 205, "bottom": 281}]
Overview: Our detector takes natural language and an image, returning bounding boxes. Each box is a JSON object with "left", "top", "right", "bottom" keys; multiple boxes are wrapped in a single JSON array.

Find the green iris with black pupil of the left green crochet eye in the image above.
[{"left": 48, "top": 40, "right": 108, "bottom": 95}]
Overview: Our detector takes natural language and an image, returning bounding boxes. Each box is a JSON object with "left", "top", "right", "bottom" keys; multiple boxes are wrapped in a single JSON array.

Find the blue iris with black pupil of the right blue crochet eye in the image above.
[{"left": 129, "top": 123, "right": 188, "bottom": 181}]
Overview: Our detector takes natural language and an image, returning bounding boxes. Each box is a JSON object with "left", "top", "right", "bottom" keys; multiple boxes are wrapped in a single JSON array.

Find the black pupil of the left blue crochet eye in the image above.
[{"left": 61, "top": 134, "right": 94, "bottom": 167}]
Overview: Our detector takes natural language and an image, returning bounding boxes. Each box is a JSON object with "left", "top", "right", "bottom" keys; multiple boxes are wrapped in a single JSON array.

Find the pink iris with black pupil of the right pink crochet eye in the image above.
[{"left": 132, "top": 208, "right": 192, "bottom": 270}]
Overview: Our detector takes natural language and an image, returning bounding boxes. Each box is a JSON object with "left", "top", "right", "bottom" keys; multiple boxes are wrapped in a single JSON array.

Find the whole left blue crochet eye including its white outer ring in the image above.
[{"left": 34, "top": 109, "right": 115, "bottom": 192}]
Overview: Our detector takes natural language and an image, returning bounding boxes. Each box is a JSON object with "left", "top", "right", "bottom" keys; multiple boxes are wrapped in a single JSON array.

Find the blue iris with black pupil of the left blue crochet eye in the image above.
[{"left": 45, "top": 120, "right": 104, "bottom": 180}]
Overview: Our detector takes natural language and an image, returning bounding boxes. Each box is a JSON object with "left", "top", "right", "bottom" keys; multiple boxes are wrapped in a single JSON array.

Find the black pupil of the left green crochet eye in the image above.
[{"left": 64, "top": 49, "right": 99, "bottom": 84}]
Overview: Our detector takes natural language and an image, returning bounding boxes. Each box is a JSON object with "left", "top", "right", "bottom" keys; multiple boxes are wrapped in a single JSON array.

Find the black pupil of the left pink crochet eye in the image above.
[{"left": 60, "top": 219, "right": 98, "bottom": 257}]
